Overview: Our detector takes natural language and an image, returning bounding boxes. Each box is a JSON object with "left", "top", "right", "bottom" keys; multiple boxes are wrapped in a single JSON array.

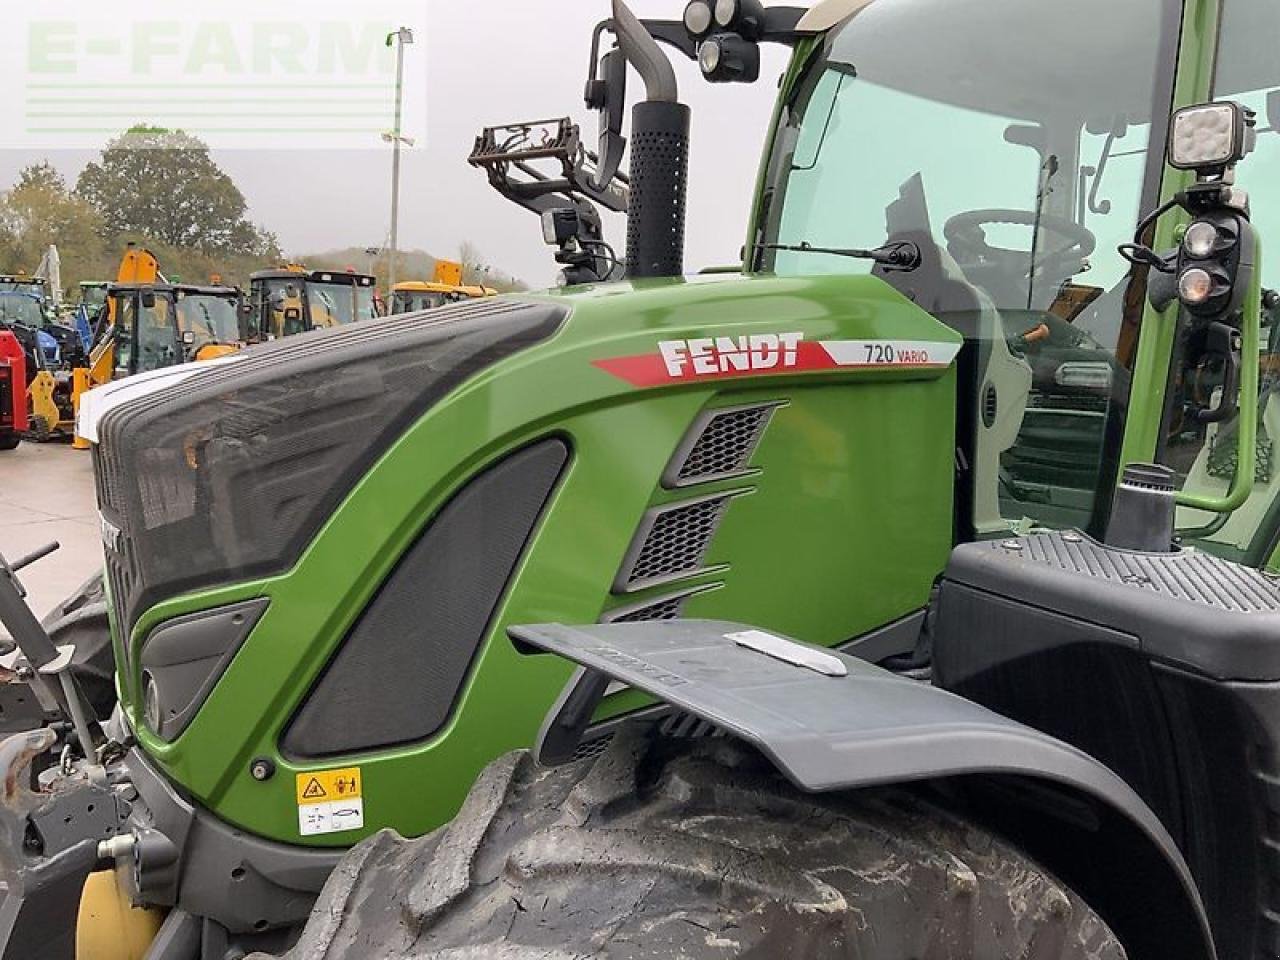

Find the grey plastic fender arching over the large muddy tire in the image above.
[{"left": 509, "top": 621, "right": 1216, "bottom": 960}]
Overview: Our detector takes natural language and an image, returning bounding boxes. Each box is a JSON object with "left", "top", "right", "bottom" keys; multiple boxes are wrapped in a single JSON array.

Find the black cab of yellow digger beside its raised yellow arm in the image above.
[{"left": 106, "top": 284, "right": 243, "bottom": 379}]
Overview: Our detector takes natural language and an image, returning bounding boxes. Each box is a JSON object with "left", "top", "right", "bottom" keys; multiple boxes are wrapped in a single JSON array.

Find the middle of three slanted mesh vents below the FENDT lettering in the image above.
[{"left": 613, "top": 493, "right": 737, "bottom": 593}]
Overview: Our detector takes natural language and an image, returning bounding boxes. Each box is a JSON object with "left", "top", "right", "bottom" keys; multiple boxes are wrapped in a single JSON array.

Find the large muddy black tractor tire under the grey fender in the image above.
[{"left": 259, "top": 732, "right": 1125, "bottom": 960}]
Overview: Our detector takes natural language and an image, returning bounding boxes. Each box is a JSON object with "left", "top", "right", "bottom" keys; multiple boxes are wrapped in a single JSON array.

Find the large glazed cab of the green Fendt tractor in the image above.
[{"left": 747, "top": 0, "right": 1280, "bottom": 561}]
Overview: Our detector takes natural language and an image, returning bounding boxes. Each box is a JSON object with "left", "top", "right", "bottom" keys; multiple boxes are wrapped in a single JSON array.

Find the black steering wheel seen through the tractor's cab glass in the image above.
[{"left": 942, "top": 209, "right": 1098, "bottom": 288}]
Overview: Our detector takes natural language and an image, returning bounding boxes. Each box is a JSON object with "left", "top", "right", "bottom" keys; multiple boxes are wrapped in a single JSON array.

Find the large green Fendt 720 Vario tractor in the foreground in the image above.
[{"left": 0, "top": 0, "right": 1280, "bottom": 960}]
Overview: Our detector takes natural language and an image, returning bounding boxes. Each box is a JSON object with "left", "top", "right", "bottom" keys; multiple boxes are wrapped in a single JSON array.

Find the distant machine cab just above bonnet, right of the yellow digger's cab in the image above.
[{"left": 242, "top": 265, "right": 378, "bottom": 343}]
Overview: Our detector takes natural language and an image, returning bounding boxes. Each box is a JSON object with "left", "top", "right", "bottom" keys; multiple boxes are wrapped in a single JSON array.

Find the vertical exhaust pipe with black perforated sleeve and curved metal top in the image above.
[{"left": 613, "top": 0, "right": 690, "bottom": 278}]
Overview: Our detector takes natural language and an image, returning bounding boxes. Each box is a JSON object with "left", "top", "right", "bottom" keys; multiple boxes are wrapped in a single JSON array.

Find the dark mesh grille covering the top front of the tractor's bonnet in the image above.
[{"left": 95, "top": 298, "right": 567, "bottom": 632}]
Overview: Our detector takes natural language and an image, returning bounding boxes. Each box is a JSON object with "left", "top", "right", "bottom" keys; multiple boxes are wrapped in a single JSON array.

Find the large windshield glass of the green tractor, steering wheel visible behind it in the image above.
[{"left": 755, "top": 0, "right": 1180, "bottom": 535}]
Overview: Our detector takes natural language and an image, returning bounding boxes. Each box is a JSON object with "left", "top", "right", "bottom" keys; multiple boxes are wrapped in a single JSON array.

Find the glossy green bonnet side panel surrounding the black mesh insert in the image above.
[{"left": 123, "top": 276, "right": 959, "bottom": 845}]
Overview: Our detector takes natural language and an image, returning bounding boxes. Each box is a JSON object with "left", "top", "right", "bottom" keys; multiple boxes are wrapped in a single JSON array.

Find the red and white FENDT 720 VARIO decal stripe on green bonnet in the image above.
[{"left": 594, "top": 332, "right": 960, "bottom": 387}]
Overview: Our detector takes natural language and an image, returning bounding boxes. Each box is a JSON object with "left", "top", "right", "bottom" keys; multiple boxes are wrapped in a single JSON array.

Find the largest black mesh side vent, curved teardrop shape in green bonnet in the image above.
[{"left": 280, "top": 439, "right": 570, "bottom": 756}]
